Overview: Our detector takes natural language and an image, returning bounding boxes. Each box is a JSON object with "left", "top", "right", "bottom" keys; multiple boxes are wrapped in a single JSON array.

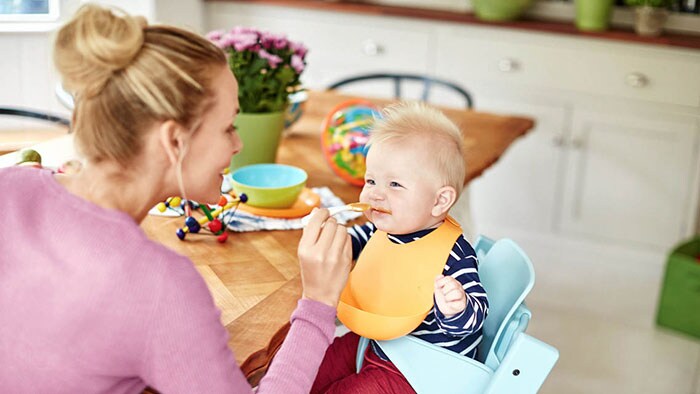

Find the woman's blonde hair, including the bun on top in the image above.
[{"left": 54, "top": 4, "right": 226, "bottom": 166}]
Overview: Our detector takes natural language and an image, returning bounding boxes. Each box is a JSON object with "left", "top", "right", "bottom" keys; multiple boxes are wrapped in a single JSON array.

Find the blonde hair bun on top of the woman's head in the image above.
[{"left": 54, "top": 4, "right": 147, "bottom": 96}]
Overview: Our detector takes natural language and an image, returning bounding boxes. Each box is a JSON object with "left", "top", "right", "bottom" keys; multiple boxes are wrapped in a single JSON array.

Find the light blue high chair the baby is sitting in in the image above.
[{"left": 356, "top": 236, "right": 559, "bottom": 394}]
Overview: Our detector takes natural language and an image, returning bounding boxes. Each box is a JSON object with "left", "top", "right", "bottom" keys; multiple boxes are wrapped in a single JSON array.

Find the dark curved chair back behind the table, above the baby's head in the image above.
[{"left": 328, "top": 73, "right": 474, "bottom": 109}]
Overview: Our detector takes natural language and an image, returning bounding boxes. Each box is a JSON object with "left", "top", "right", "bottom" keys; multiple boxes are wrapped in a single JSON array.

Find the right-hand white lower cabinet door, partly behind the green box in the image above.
[{"left": 560, "top": 111, "right": 699, "bottom": 247}]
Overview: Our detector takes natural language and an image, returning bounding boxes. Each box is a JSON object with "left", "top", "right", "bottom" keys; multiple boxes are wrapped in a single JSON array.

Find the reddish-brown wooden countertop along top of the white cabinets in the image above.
[{"left": 211, "top": 0, "right": 700, "bottom": 49}]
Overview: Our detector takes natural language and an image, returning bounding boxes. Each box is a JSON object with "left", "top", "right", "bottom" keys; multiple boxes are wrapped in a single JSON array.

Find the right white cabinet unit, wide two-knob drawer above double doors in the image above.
[{"left": 436, "top": 26, "right": 700, "bottom": 250}]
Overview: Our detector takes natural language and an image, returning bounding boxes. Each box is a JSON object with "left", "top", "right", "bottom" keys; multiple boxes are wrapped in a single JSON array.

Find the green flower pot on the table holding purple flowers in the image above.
[{"left": 231, "top": 111, "right": 285, "bottom": 172}]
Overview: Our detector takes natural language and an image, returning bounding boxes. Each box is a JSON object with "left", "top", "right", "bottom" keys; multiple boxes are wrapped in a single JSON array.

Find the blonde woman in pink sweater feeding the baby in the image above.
[{"left": 0, "top": 5, "right": 351, "bottom": 393}]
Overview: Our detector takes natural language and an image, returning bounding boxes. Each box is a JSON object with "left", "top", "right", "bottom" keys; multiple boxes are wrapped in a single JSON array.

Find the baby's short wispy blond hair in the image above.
[{"left": 369, "top": 102, "right": 466, "bottom": 197}]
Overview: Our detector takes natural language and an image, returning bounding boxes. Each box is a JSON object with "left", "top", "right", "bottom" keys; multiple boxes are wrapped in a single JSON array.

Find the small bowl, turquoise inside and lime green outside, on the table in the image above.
[{"left": 231, "top": 164, "right": 308, "bottom": 209}]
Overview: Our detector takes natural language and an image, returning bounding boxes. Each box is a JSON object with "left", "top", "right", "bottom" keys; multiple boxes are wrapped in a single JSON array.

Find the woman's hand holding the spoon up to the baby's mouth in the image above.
[{"left": 297, "top": 208, "right": 352, "bottom": 308}]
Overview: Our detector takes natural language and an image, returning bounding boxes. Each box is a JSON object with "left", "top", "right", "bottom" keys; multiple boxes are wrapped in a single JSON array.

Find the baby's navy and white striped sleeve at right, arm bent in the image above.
[{"left": 433, "top": 235, "right": 489, "bottom": 337}]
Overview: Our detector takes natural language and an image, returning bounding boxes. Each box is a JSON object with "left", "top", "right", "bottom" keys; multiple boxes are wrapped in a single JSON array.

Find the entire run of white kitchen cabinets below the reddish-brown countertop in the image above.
[{"left": 208, "top": 2, "right": 700, "bottom": 251}]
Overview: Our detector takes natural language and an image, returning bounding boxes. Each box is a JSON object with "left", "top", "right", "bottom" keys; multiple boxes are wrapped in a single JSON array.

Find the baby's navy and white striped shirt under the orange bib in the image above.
[{"left": 348, "top": 222, "right": 489, "bottom": 360}]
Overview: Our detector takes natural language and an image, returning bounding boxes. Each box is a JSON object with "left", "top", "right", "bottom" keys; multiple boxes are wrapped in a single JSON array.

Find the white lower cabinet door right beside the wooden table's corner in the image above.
[{"left": 470, "top": 95, "right": 569, "bottom": 234}]
